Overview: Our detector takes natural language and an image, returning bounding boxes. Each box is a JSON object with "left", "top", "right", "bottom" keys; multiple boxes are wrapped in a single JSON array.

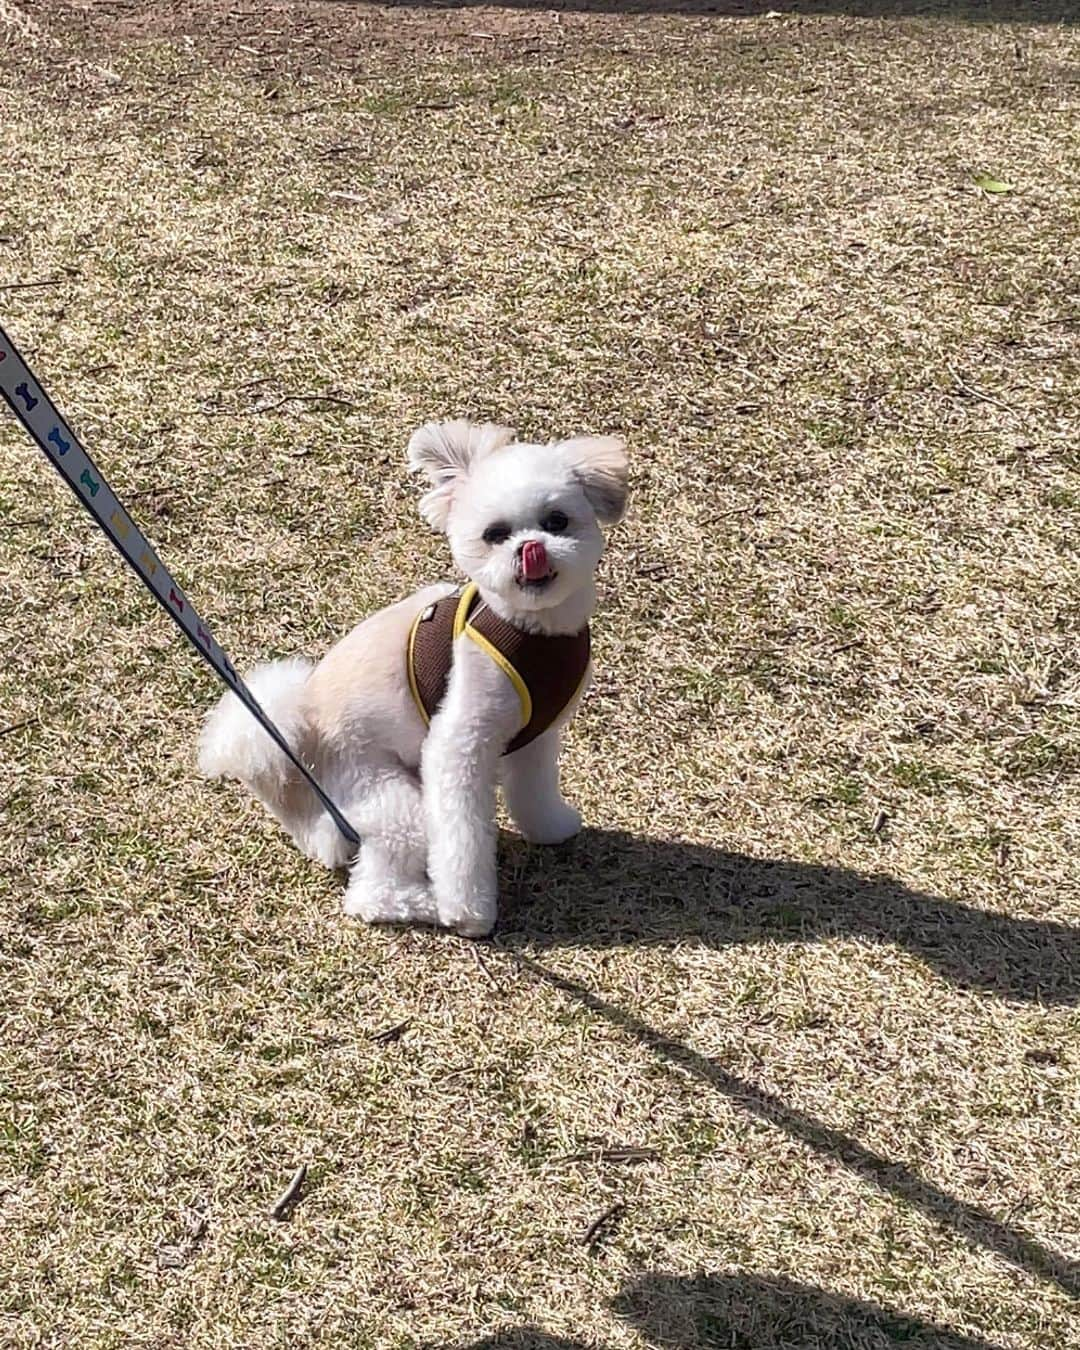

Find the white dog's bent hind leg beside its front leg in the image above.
[{"left": 343, "top": 765, "right": 436, "bottom": 923}]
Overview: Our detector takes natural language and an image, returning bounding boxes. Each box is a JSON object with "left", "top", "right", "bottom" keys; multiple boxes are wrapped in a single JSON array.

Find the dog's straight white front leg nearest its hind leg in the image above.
[{"left": 421, "top": 636, "right": 522, "bottom": 937}]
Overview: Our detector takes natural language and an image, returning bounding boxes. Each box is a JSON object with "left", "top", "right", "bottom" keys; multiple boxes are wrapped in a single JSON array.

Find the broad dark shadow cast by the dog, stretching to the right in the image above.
[{"left": 498, "top": 830, "right": 1080, "bottom": 1004}]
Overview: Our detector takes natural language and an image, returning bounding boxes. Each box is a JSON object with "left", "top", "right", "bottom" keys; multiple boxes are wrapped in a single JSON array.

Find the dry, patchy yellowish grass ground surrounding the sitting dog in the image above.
[{"left": 0, "top": 0, "right": 1080, "bottom": 1350}]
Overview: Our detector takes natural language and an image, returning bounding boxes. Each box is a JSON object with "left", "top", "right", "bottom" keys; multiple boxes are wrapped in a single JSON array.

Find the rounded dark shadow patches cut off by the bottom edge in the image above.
[{"left": 463, "top": 1274, "right": 1015, "bottom": 1350}]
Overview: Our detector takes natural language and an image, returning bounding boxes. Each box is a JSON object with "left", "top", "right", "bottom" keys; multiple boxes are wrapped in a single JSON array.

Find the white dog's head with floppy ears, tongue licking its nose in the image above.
[{"left": 409, "top": 421, "right": 626, "bottom": 613}]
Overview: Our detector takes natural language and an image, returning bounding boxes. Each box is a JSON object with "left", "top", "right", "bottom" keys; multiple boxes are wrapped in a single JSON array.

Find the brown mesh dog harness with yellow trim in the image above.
[{"left": 408, "top": 582, "right": 590, "bottom": 755}]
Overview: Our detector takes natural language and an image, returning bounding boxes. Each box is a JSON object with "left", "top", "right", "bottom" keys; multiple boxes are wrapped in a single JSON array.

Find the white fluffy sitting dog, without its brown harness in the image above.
[{"left": 198, "top": 421, "right": 626, "bottom": 936}]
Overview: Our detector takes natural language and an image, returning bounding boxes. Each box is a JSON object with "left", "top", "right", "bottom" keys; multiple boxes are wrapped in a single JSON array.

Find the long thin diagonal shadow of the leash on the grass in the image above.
[{"left": 500, "top": 945, "right": 1080, "bottom": 1297}]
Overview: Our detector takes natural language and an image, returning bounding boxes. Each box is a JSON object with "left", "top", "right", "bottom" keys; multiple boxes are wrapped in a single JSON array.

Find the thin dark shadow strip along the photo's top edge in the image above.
[{"left": 332, "top": 0, "right": 1077, "bottom": 23}]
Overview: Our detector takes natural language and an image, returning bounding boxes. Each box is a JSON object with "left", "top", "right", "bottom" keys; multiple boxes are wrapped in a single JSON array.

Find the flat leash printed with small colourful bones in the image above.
[{"left": 0, "top": 327, "right": 360, "bottom": 846}]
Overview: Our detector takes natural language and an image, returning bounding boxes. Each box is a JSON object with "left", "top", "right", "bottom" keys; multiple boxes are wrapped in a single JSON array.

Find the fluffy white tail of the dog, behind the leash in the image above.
[{"left": 198, "top": 656, "right": 313, "bottom": 809}]
